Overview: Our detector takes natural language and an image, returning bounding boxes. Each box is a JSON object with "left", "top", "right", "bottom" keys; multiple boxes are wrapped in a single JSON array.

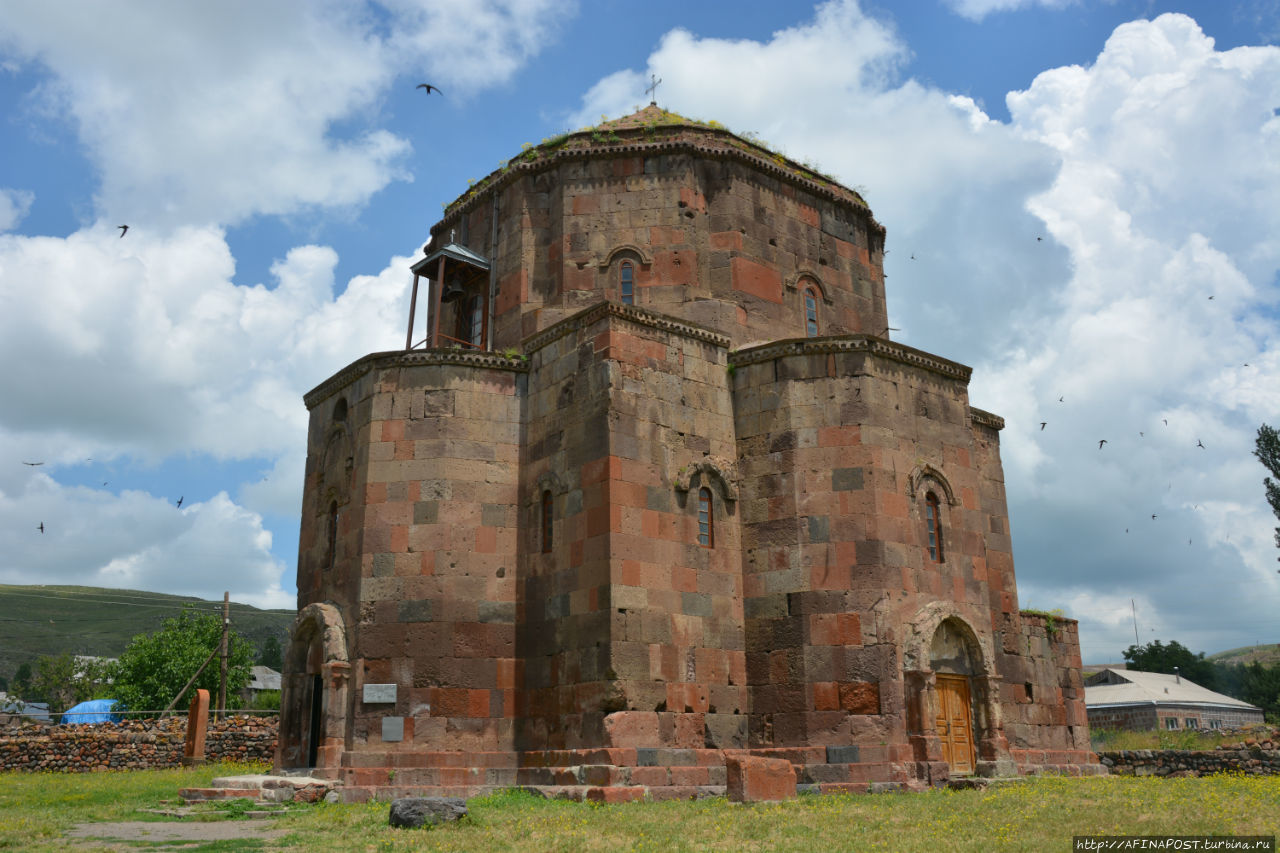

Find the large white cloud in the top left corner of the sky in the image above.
[{"left": 0, "top": 0, "right": 564, "bottom": 225}]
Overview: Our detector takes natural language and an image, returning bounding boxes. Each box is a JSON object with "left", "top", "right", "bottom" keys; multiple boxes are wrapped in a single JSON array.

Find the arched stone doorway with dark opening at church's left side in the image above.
[{"left": 275, "top": 603, "right": 351, "bottom": 770}]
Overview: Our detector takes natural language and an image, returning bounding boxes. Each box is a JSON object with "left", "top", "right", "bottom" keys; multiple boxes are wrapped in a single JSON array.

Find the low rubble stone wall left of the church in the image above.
[{"left": 0, "top": 716, "right": 279, "bottom": 772}]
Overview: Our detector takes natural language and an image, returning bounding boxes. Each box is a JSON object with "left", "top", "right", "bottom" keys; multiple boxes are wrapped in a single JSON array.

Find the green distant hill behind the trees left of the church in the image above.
[{"left": 0, "top": 584, "right": 297, "bottom": 680}]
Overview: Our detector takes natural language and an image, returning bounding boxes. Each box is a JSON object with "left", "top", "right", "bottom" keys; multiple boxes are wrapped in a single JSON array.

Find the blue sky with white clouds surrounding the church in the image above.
[{"left": 0, "top": 0, "right": 1280, "bottom": 662}]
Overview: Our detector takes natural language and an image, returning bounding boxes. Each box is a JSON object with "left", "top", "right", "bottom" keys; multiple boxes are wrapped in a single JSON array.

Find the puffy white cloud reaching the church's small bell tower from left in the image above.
[{"left": 0, "top": 225, "right": 408, "bottom": 461}]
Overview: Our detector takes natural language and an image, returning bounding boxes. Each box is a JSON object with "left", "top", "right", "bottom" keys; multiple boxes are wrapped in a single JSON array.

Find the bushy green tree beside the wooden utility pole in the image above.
[{"left": 111, "top": 606, "right": 253, "bottom": 716}]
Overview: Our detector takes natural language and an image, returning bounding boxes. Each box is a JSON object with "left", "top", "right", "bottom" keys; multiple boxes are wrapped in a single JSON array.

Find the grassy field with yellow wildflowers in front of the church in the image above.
[{"left": 0, "top": 766, "right": 1280, "bottom": 853}]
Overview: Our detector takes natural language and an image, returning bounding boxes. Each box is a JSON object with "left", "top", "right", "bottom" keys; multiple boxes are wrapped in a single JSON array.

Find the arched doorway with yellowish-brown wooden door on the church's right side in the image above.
[{"left": 929, "top": 619, "right": 983, "bottom": 775}]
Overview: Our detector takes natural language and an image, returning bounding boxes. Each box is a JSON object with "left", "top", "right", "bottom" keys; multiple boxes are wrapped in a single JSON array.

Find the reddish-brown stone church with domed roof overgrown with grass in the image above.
[{"left": 276, "top": 105, "right": 1101, "bottom": 800}]
